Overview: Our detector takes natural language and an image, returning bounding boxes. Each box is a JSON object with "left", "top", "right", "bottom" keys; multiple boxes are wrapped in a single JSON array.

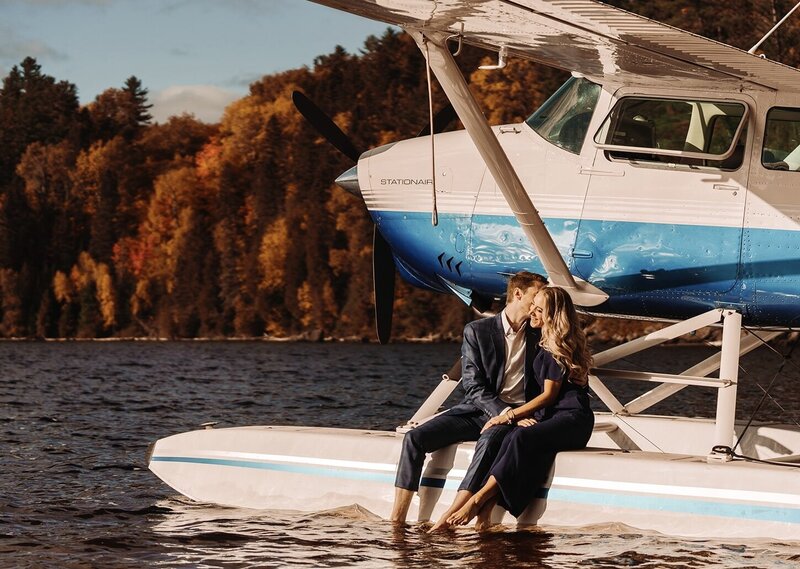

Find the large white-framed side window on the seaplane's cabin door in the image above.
[{"left": 595, "top": 97, "right": 746, "bottom": 170}]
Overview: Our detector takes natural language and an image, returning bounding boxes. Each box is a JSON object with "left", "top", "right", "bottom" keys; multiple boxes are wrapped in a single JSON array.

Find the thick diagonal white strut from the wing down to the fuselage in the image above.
[{"left": 406, "top": 30, "right": 608, "bottom": 306}]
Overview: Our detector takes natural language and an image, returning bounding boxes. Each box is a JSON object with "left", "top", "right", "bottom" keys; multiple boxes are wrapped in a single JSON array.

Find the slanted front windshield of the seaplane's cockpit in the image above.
[{"left": 525, "top": 77, "right": 600, "bottom": 154}]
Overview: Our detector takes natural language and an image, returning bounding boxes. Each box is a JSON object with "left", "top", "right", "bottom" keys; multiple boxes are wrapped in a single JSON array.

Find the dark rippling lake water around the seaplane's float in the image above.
[{"left": 0, "top": 342, "right": 800, "bottom": 569}]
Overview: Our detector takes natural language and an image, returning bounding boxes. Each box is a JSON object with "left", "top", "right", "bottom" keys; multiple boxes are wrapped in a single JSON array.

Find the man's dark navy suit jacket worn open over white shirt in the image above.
[{"left": 447, "top": 311, "right": 541, "bottom": 417}]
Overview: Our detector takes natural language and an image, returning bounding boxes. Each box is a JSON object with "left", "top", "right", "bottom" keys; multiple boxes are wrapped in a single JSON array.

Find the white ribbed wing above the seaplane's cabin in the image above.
[{"left": 312, "top": 0, "right": 800, "bottom": 92}]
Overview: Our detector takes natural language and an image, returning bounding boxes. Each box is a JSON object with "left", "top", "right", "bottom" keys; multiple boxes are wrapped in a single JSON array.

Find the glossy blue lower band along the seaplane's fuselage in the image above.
[{"left": 373, "top": 211, "right": 800, "bottom": 325}]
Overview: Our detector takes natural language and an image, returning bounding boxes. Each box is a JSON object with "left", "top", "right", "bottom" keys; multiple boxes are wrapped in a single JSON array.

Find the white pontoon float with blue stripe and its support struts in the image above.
[{"left": 148, "top": 309, "right": 800, "bottom": 541}]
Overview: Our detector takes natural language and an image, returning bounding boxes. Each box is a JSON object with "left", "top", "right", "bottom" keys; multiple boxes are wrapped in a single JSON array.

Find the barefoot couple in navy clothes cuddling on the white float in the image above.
[{"left": 391, "top": 272, "right": 594, "bottom": 531}]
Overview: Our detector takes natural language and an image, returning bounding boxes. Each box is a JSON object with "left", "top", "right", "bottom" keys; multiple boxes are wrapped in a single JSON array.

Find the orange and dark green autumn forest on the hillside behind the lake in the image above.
[{"left": 0, "top": 0, "right": 800, "bottom": 339}]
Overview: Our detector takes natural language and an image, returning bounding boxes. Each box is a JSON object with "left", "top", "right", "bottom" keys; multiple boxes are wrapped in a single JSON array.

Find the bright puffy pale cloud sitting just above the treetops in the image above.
[{"left": 150, "top": 85, "right": 244, "bottom": 123}]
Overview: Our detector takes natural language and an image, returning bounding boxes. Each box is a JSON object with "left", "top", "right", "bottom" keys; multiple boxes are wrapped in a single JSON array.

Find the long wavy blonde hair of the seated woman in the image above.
[{"left": 536, "top": 286, "right": 592, "bottom": 385}]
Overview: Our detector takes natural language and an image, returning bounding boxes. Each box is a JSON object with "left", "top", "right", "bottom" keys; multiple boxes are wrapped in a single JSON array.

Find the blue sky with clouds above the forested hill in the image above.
[{"left": 0, "top": 0, "right": 396, "bottom": 122}]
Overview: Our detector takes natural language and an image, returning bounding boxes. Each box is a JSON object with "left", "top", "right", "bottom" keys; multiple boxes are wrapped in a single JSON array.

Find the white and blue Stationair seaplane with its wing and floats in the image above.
[{"left": 148, "top": 0, "right": 800, "bottom": 541}]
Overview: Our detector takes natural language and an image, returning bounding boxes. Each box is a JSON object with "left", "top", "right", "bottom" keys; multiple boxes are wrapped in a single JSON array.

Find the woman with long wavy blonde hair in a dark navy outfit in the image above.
[{"left": 446, "top": 287, "right": 594, "bottom": 530}]
